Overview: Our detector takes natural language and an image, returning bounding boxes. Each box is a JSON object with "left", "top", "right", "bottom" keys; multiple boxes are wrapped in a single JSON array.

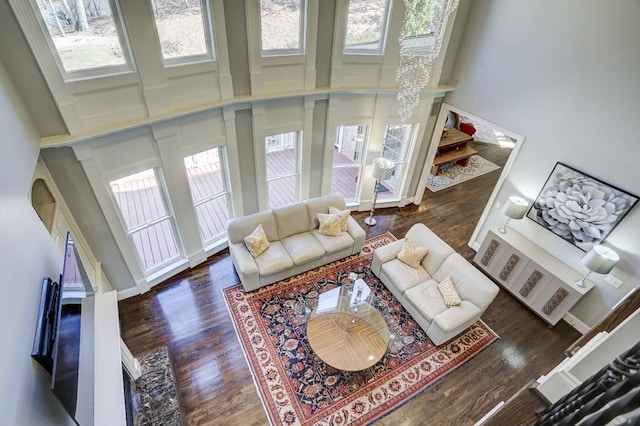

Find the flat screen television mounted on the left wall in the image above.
[{"left": 51, "top": 233, "right": 93, "bottom": 423}]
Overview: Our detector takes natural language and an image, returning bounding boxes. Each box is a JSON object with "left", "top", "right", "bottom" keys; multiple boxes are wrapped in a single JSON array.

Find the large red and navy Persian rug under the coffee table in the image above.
[{"left": 223, "top": 233, "right": 498, "bottom": 425}]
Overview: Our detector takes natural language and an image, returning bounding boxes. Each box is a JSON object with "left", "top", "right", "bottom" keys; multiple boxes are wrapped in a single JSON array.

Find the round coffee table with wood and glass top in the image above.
[{"left": 307, "top": 289, "right": 390, "bottom": 371}]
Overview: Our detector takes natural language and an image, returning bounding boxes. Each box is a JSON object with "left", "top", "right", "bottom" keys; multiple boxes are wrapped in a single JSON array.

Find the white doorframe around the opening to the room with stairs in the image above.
[{"left": 413, "top": 102, "right": 525, "bottom": 250}]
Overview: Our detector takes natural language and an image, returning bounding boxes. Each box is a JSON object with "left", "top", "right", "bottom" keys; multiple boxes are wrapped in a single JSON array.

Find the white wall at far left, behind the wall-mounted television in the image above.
[{"left": 0, "top": 65, "right": 72, "bottom": 426}]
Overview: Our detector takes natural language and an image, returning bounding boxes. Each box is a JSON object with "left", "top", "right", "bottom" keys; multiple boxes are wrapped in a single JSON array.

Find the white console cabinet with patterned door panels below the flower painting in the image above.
[{"left": 473, "top": 229, "right": 594, "bottom": 325}]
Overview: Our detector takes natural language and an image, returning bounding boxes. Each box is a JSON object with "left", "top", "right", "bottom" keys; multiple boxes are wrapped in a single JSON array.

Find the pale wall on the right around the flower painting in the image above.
[{"left": 446, "top": 0, "right": 640, "bottom": 326}]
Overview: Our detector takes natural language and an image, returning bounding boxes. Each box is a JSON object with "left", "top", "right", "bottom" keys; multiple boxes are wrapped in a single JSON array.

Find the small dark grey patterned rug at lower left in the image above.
[{"left": 131, "top": 346, "right": 183, "bottom": 426}]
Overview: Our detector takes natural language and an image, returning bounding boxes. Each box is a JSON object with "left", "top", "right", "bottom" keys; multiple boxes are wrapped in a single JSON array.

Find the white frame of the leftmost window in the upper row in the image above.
[{"left": 29, "top": 0, "right": 136, "bottom": 83}]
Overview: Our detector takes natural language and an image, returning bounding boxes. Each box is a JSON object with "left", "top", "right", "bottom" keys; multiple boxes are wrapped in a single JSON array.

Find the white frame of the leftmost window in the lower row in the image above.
[{"left": 105, "top": 165, "right": 185, "bottom": 272}]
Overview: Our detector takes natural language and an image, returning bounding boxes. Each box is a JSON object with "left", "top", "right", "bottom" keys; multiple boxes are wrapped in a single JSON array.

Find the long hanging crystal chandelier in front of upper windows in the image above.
[{"left": 396, "top": 0, "right": 459, "bottom": 123}]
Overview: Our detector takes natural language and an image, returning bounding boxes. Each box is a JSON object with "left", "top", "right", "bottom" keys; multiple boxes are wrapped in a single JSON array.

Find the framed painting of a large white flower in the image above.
[{"left": 527, "top": 163, "right": 638, "bottom": 251}]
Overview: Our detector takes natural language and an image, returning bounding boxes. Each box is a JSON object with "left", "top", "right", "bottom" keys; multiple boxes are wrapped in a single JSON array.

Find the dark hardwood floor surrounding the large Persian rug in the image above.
[{"left": 120, "top": 143, "right": 580, "bottom": 425}]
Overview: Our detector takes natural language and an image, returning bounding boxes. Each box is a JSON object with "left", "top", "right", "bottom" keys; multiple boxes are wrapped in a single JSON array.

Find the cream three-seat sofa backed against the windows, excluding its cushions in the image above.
[{"left": 227, "top": 194, "right": 365, "bottom": 291}]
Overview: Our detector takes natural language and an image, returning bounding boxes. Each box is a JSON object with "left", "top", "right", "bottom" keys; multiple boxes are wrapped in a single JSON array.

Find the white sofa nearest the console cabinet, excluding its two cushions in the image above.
[{"left": 371, "top": 223, "right": 499, "bottom": 345}]
